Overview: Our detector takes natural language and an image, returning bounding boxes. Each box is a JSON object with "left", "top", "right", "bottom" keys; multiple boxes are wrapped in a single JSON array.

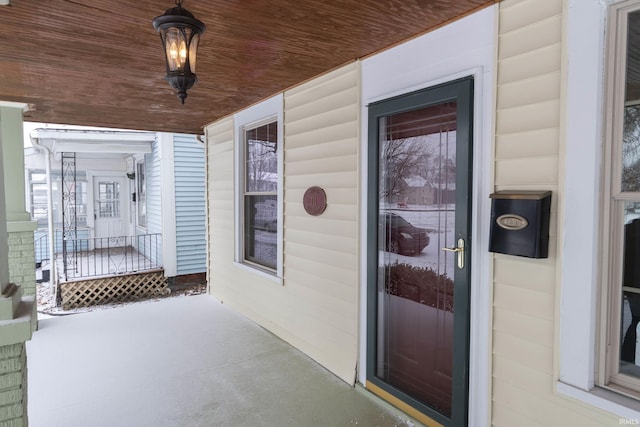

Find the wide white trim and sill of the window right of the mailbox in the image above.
[{"left": 556, "top": 0, "right": 640, "bottom": 419}]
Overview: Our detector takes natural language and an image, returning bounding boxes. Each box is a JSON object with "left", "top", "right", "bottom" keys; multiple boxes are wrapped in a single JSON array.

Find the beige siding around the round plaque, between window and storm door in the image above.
[{"left": 284, "top": 63, "right": 360, "bottom": 383}]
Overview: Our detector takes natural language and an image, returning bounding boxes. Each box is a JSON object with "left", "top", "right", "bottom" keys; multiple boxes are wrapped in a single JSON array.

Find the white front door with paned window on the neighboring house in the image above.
[{"left": 93, "top": 176, "right": 128, "bottom": 248}]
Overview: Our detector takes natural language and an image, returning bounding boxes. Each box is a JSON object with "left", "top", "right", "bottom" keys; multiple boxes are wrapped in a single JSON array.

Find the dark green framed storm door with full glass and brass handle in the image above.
[{"left": 367, "top": 78, "right": 473, "bottom": 426}]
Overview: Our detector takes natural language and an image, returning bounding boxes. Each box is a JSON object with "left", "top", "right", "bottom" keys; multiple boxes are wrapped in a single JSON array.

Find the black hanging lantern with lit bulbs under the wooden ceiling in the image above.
[{"left": 153, "top": 0, "right": 206, "bottom": 104}]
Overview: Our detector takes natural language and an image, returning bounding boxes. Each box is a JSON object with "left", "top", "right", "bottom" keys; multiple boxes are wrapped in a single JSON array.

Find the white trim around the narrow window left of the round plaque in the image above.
[{"left": 233, "top": 94, "right": 284, "bottom": 283}]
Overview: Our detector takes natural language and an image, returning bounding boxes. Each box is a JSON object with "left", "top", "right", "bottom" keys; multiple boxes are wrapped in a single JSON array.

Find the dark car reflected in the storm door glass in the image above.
[{"left": 378, "top": 212, "right": 430, "bottom": 255}]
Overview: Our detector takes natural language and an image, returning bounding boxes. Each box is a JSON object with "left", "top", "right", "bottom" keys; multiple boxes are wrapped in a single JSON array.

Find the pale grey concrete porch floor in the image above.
[{"left": 27, "top": 295, "right": 421, "bottom": 427}]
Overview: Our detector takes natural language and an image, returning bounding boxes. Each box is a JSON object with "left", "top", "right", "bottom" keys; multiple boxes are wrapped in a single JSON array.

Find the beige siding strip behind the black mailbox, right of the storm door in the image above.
[{"left": 492, "top": 0, "right": 618, "bottom": 427}]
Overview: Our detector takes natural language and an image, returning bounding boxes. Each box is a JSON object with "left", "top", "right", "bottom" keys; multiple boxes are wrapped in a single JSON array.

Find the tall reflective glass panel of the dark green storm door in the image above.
[{"left": 376, "top": 102, "right": 457, "bottom": 417}]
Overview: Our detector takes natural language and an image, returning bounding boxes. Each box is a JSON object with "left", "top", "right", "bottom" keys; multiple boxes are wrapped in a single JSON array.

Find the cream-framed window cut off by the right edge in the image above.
[{"left": 598, "top": 1, "right": 640, "bottom": 398}]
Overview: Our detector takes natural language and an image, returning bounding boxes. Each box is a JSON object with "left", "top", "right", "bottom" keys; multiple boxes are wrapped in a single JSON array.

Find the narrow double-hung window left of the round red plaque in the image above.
[{"left": 242, "top": 120, "right": 279, "bottom": 272}]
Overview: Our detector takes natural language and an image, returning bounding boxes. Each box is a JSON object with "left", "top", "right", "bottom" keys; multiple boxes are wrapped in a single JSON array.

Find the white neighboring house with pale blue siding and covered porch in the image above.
[{"left": 25, "top": 128, "right": 206, "bottom": 306}]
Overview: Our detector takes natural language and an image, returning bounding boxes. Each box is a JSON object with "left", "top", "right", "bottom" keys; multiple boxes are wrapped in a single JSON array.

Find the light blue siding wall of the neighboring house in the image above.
[{"left": 173, "top": 135, "right": 206, "bottom": 275}]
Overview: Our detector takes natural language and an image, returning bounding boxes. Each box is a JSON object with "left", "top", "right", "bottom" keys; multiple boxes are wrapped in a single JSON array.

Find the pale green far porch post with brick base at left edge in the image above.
[{"left": 0, "top": 102, "right": 38, "bottom": 295}]
